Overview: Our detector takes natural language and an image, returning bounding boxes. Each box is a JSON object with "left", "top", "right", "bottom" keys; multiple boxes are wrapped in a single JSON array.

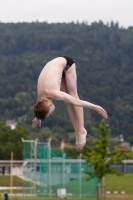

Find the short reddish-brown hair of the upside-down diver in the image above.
[{"left": 34, "top": 98, "right": 50, "bottom": 120}]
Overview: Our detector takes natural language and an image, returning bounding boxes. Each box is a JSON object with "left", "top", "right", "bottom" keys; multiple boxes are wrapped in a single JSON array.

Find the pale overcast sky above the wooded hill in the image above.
[{"left": 0, "top": 0, "right": 133, "bottom": 28}]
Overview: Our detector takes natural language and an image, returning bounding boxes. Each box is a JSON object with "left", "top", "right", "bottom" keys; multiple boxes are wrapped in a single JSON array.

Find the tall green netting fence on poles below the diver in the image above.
[{"left": 24, "top": 141, "right": 98, "bottom": 198}]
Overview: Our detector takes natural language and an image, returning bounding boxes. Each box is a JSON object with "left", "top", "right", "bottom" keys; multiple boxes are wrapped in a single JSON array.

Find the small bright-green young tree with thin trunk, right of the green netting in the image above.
[{"left": 83, "top": 119, "right": 132, "bottom": 197}]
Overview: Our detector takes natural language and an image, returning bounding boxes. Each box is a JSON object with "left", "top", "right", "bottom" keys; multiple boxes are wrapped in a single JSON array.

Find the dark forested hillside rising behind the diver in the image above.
[{"left": 0, "top": 21, "right": 133, "bottom": 143}]
